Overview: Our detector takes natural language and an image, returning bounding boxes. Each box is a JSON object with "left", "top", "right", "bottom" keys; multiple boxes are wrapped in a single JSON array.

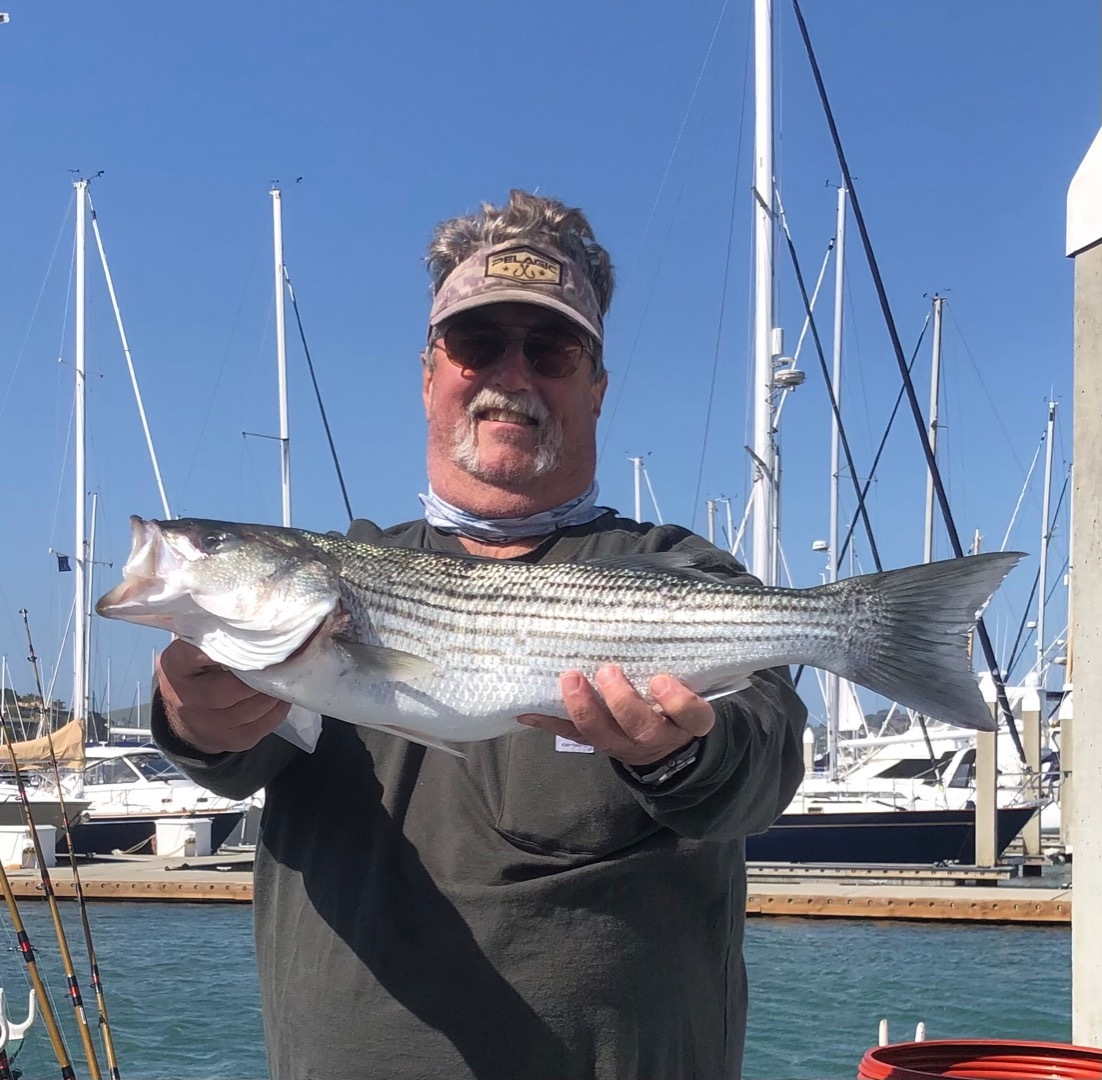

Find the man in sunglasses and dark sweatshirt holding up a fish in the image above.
[{"left": 153, "top": 191, "right": 806, "bottom": 1080}]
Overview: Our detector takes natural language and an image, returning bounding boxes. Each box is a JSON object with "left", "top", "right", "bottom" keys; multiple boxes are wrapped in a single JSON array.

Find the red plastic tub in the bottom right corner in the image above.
[{"left": 857, "top": 1039, "right": 1102, "bottom": 1080}]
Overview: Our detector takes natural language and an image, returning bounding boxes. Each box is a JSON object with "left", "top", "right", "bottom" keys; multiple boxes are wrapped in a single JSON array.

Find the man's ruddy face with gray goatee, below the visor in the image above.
[{"left": 422, "top": 303, "right": 607, "bottom": 505}]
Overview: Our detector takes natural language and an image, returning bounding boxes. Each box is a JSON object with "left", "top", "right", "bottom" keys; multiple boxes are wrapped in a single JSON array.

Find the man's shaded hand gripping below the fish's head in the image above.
[{"left": 156, "top": 639, "right": 291, "bottom": 754}]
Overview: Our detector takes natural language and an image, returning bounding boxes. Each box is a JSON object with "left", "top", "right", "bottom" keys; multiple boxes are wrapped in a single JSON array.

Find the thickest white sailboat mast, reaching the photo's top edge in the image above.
[{"left": 750, "top": 0, "right": 779, "bottom": 585}]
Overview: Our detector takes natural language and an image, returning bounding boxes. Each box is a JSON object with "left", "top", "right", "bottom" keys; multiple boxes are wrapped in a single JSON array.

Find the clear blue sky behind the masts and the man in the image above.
[{"left": 0, "top": 6, "right": 1102, "bottom": 709}]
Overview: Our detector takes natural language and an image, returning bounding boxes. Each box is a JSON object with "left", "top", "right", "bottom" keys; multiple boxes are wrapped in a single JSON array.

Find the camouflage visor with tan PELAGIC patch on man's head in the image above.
[{"left": 429, "top": 240, "right": 604, "bottom": 342}]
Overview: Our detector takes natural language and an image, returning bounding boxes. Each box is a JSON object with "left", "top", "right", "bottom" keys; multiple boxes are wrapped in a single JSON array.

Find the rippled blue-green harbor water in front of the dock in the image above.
[{"left": 0, "top": 901, "right": 1071, "bottom": 1080}]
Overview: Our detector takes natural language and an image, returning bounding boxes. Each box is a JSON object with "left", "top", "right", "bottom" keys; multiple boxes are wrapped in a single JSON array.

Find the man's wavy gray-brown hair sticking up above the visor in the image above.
[{"left": 425, "top": 187, "right": 615, "bottom": 381}]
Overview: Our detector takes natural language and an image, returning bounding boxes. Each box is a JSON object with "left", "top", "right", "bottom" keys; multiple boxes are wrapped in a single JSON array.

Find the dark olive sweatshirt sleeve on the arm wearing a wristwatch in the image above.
[{"left": 613, "top": 537, "right": 808, "bottom": 840}]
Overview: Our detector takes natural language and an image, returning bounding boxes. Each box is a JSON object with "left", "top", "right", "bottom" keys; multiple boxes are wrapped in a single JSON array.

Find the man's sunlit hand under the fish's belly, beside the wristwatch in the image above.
[{"left": 517, "top": 665, "right": 715, "bottom": 765}]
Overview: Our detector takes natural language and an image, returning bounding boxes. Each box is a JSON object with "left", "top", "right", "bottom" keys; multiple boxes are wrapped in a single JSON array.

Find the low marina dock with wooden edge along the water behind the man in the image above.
[{"left": 8, "top": 850, "right": 1071, "bottom": 925}]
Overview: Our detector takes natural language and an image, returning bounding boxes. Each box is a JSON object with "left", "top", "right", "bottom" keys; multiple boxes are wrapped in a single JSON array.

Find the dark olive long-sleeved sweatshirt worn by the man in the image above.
[{"left": 153, "top": 512, "right": 807, "bottom": 1080}]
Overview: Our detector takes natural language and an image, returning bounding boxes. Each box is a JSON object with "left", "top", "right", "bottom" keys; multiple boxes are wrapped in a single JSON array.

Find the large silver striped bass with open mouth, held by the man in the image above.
[{"left": 96, "top": 516, "right": 1022, "bottom": 752}]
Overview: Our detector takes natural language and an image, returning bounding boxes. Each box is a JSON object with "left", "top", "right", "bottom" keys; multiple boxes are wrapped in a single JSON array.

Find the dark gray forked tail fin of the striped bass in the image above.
[{"left": 821, "top": 551, "right": 1023, "bottom": 731}]
